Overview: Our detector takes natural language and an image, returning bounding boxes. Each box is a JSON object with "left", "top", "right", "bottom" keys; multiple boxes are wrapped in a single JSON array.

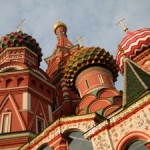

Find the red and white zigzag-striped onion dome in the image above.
[{"left": 117, "top": 28, "right": 150, "bottom": 73}]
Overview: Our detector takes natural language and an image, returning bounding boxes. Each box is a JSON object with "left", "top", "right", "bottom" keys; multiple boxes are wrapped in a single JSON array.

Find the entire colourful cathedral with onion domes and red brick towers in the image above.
[{"left": 0, "top": 22, "right": 150, "bottom": 150}]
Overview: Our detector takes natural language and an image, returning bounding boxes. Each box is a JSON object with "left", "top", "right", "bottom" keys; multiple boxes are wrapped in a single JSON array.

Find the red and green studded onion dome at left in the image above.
[{"left": 0, "top": 31, "right": 42, "bottom": 64}]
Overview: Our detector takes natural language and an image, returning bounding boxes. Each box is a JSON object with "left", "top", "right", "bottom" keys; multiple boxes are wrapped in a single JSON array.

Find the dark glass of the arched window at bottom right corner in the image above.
[{"left": 124, "top": 140, "right": 148, "bottom": 150}]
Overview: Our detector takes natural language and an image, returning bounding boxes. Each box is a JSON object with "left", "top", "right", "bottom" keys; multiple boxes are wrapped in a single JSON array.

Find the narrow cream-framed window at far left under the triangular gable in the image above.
[{"left": 1, "top": 112, "right": 11, "bottom": 133}]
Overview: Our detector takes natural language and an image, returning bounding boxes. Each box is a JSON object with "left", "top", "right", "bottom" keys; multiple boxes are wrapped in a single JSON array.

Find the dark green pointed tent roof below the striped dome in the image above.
[{"left": 123, "top": 58, "right": 150, "bottom": 105}]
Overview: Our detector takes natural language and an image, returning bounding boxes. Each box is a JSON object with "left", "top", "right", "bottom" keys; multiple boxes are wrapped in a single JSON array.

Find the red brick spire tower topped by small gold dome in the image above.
[{"left": 45, "top": 22, "right": 79, "bottom": 120}]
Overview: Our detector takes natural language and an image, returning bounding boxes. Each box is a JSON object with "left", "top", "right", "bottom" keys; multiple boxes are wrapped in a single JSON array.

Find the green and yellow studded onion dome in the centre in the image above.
[{"left": 65, "top": 47, "right": 119, "bottom": 87}]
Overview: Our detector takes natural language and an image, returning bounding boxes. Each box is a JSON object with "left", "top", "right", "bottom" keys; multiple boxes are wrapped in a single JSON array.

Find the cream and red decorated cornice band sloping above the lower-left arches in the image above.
[{"left": 21, "top": 114, "right": 98, "bottom": 150}]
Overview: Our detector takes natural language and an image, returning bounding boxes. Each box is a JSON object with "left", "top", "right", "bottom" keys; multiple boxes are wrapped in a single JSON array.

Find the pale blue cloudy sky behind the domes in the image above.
[{"left": 0, "top": 0, "right": 150, "bottom": 89}]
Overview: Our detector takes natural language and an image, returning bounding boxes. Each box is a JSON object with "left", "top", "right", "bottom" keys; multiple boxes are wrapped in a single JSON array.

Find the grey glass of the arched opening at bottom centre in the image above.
[{"left": 68, "top": 132, "right": 93, "bottom": 150}]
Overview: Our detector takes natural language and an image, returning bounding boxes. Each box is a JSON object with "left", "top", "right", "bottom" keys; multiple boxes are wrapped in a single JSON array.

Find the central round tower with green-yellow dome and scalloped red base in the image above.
[{"left": 65, "top": 47, "right": 122, "bottom": 117}]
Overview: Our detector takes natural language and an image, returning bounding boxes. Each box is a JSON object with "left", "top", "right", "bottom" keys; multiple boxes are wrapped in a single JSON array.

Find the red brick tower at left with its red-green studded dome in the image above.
[{"left": 0, "top": 31, "right": 55, "bottom": 150}]
